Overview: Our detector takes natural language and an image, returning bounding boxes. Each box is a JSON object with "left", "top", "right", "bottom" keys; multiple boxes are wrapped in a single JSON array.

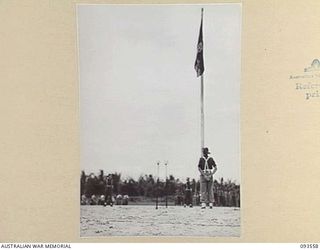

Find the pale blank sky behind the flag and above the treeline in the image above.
[{"left": 77, "top": 4, "right": 241, "bottom": 183}]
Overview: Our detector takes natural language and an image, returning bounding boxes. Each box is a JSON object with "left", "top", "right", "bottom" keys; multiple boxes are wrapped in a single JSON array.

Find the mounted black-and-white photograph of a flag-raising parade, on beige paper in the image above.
[{"left": 77, "top": 3, "right": 240, "bottom": 237}]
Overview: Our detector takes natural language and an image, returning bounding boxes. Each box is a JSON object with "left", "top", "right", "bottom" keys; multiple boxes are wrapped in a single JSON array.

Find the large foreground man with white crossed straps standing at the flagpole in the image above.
[{"left": 198, "top": 148, "right": 217, "bottom": 209}]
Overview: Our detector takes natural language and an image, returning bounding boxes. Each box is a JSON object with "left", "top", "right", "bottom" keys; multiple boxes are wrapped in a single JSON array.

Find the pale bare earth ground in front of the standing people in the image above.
[{"left": 80, "top": 205, "right": 240, "bottom": 237}]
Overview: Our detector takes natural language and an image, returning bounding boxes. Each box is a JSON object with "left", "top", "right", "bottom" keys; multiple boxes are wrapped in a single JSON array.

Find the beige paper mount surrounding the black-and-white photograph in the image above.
[{"left": 0, "top": 0, "right": 320, "bottom": 242}]
